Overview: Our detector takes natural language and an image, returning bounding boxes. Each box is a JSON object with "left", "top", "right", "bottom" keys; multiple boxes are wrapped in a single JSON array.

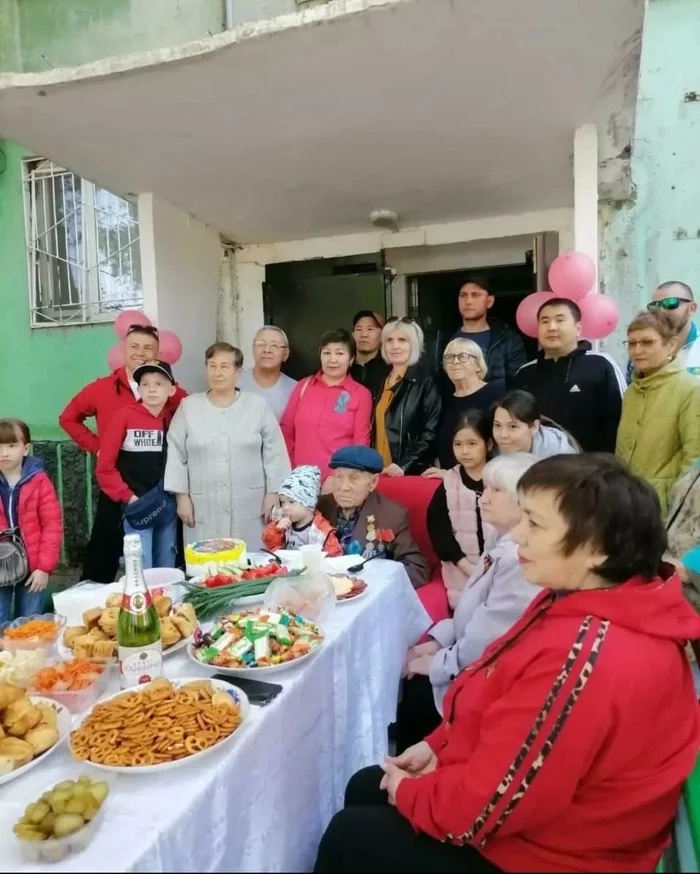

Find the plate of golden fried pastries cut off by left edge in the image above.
[{"left": 0, "top": 683, "right": 72, "bottom": 784}]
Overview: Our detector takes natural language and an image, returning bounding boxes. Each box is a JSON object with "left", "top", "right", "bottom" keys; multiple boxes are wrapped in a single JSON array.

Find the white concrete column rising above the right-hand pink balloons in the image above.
[{"left": 574, "top": 124, "right": 598, "bottom": 287}]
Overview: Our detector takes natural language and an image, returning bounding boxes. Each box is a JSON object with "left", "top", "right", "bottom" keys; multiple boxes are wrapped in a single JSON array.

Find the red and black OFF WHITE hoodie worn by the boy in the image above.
[{"left": 95, "top": 398, "right": 172, "bottom": 504}]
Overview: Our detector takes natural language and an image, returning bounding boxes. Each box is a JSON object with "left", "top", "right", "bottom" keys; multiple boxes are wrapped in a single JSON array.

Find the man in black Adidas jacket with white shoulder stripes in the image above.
[{"left": 513, "top": 297, "right": 626, "bottom": 452}]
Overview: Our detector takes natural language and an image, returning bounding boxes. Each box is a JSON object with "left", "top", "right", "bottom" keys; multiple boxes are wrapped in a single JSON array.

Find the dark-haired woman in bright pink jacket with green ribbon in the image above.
[{"left": 280, "top": 329, "right": 372, "bottom": 479}]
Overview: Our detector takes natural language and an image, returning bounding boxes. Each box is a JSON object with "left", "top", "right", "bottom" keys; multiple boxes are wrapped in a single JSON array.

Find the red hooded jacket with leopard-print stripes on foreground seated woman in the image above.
[{"left": 396, "top": 569, "right": 700, "bottom": 872}]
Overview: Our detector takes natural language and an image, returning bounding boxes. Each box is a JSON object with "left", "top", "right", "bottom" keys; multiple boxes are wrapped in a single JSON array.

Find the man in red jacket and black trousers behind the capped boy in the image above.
[{"left": 58, "top": 325, "right": 187, "bottom": 583}]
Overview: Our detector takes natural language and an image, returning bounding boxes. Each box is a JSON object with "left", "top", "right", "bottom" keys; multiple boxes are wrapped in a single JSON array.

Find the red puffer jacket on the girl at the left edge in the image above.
[{"left": 0, "top": 456, "right": 63, "bottom": 574}]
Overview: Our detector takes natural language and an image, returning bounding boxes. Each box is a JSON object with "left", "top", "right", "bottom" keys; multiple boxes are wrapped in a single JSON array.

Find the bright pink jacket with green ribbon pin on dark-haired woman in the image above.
[{"left": 280, "top": 373, "right": 372, "bottom": 479}]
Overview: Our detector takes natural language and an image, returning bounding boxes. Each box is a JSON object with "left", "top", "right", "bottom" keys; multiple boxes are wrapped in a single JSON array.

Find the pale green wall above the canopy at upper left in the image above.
[{"left": 0, "top": 0, "right": 224, "bottom": 72}]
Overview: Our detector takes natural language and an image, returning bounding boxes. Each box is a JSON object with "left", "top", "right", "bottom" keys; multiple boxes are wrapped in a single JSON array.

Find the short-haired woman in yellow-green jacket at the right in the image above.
[{"left": 615, "top": 308, "right": 700, "bottom": 516}]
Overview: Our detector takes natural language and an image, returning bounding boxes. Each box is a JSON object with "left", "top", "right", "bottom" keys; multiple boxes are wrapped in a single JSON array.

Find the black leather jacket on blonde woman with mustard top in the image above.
[{"left": 372, "top": 363, "right": 442, "bottom": 476}]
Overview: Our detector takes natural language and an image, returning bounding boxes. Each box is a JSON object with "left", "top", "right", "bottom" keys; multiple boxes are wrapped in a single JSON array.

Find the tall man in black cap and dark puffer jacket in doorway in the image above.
[{"left": 433, "top": 276, "right": 527, "bottom": 394}]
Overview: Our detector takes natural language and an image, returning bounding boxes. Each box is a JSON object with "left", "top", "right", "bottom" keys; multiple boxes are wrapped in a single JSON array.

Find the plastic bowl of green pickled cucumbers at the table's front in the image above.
[{"left": 12, "top": 776, "right": 109, "bottom": 862}]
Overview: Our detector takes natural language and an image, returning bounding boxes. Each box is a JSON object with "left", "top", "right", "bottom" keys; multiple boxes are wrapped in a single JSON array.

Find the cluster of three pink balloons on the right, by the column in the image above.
[{"left": 515, "top": 252, "right": 620, "bottom": 340}]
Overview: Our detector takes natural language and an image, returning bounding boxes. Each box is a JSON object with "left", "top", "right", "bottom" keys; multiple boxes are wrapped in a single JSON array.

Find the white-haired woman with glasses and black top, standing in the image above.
[{"left": 426, "top": 337, "right": 505, "bottom": 476}]
